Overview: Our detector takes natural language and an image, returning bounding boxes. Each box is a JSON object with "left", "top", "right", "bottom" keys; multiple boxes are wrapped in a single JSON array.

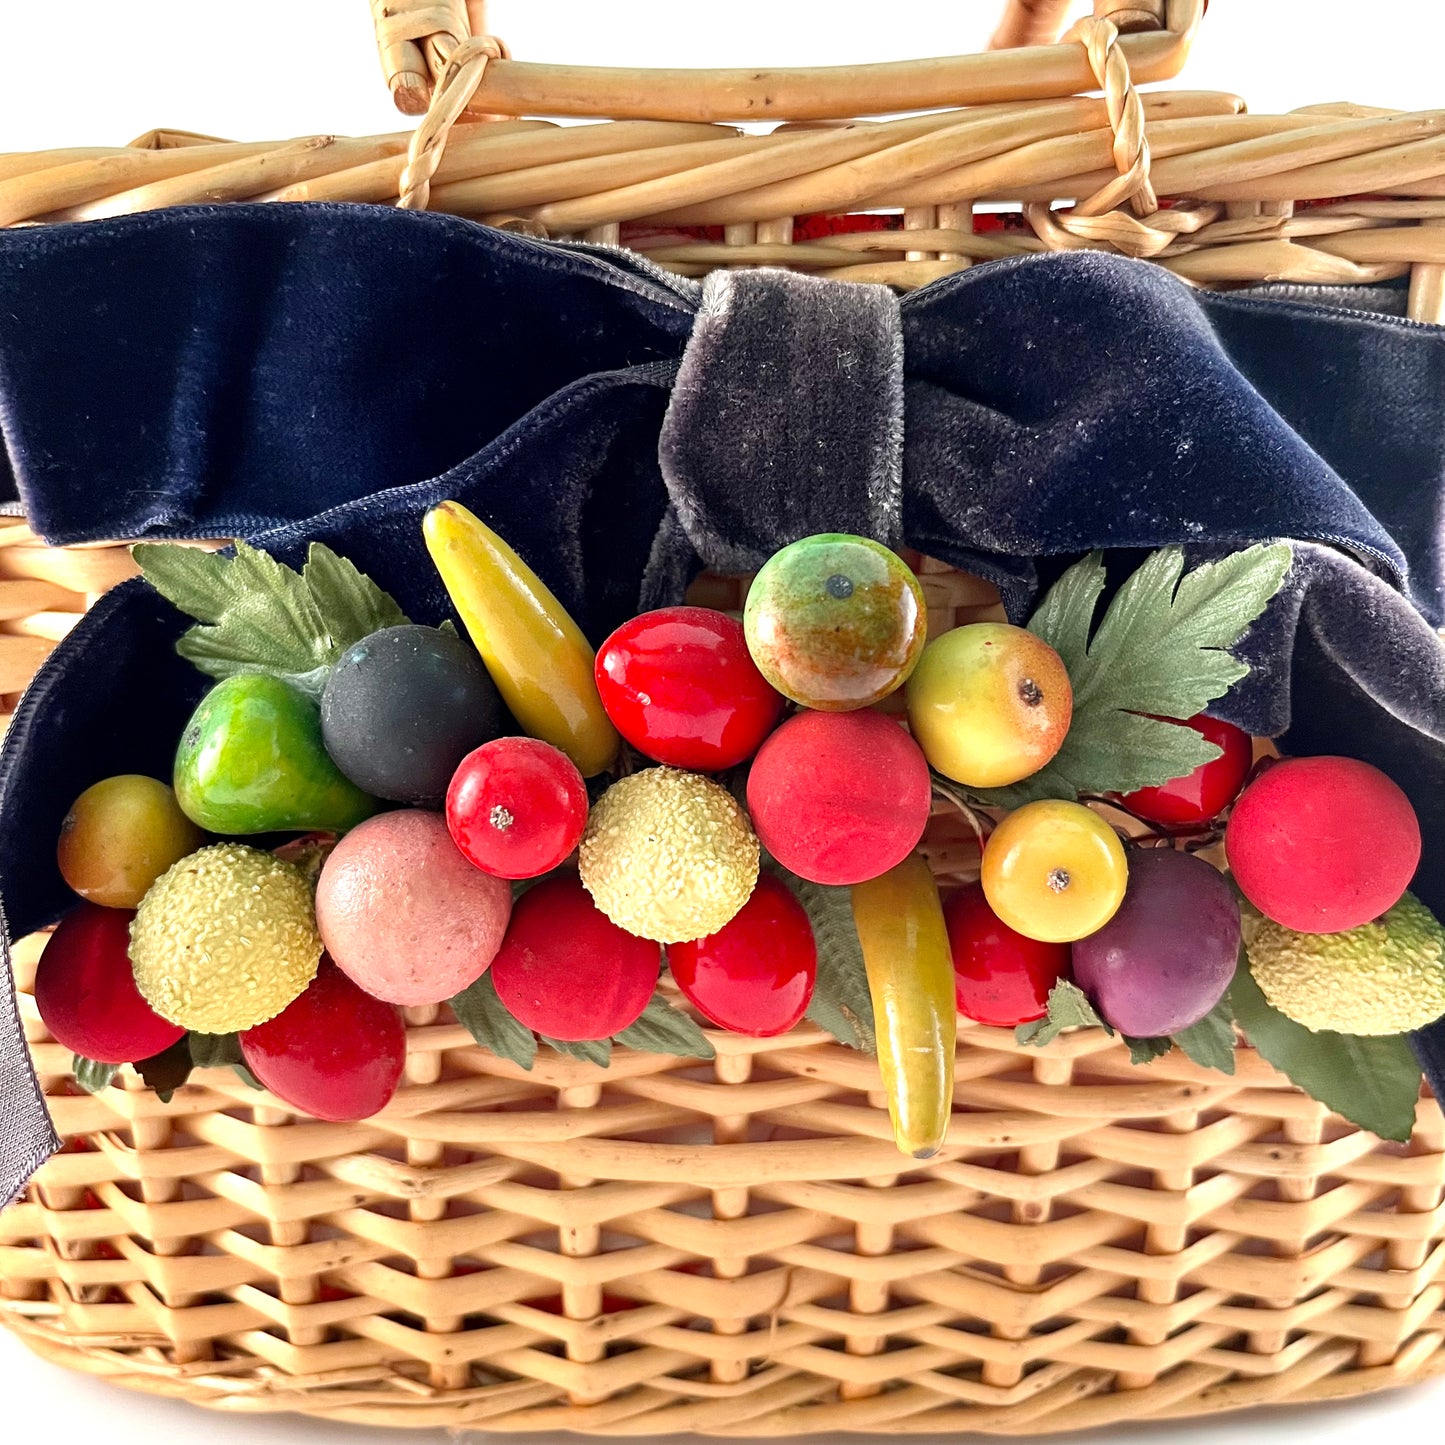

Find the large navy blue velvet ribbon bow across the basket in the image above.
[{"left": 0, "top": 205, "right": 1445, "bottom": 1196}]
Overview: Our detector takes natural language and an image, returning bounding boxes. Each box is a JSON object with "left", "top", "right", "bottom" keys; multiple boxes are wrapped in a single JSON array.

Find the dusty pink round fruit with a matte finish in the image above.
[{"left": 316, "top": 808, "right": 512, "bottom": 1006}]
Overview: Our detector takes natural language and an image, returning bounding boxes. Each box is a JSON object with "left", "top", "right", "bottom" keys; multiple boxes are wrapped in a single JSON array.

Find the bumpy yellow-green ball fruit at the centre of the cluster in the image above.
[{"left": 579, "top": 767, "right": 759, "bottom": 944}]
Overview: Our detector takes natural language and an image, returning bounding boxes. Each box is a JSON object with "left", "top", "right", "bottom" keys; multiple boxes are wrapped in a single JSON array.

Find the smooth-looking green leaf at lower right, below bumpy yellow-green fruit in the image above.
[{"left": 1230, "top": 951, "right": 1420, "bottom": 1143}]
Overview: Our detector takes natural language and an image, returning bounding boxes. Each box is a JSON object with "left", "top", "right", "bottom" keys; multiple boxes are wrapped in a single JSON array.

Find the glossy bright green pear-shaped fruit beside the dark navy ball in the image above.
[{"left": 175, "top": 672, "right": 377, "bottom": 834}]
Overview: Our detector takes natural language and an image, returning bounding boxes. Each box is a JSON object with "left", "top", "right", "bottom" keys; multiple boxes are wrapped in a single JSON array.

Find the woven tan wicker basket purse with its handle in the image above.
[{"left": 0, "top": 0, "right": 1445, "bottom": 1436}]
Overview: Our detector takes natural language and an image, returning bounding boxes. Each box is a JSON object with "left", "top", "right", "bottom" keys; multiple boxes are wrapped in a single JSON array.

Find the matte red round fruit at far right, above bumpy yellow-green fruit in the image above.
[{"left": 1224, "top": 757, "right": 1420, "bottom": 933}]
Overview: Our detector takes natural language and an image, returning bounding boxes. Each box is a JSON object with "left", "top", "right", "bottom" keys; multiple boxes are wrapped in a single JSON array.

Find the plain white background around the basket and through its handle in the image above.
[{"left": 0, "top": 0, "right": 1445, "bottom": 1445}]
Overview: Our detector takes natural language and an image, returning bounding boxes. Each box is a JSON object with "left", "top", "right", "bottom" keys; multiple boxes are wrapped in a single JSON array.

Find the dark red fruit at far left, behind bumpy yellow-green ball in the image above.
[{"left": 35, "top": 903, "right": 185, "bottom": 1064}]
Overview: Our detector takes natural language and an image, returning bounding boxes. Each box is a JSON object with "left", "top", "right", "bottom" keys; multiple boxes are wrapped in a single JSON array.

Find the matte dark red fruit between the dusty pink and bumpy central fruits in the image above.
[{"left": 491, "top": 877, "right": 662, "bottom": 1040}]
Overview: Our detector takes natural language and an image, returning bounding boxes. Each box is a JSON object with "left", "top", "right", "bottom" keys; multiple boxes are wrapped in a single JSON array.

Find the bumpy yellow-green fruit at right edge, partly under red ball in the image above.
[{"left": 1244, "top": 893, "right": 1445, "bottom": 1035}]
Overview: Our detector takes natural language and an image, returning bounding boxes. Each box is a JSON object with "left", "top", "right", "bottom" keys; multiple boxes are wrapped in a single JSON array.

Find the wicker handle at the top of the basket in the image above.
[{"left": 371, "top": 0, "right": 1205, "bottom": 121}]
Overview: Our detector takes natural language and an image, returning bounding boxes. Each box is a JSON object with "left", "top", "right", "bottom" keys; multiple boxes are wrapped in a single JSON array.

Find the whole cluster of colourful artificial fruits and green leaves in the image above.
[{"left": 36, "top": 514, "right": 1445, "bottom": 1159}]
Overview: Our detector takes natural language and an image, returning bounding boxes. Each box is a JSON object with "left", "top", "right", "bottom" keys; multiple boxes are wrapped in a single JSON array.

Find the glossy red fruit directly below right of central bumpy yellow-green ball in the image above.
[{"left": 668, "top": 873, "right": 818, "bottom": 1039}]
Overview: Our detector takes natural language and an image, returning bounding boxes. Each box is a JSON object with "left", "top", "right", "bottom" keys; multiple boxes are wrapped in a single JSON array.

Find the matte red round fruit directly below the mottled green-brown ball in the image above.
[{"left": 747, "top": 711, "right": 932, "bottom": 884}]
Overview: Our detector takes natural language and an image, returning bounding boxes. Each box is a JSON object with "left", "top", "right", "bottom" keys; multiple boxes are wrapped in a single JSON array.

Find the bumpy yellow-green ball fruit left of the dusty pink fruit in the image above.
[{"left": 130, "top": 842, "right": 321, "bottom": 1033}]
